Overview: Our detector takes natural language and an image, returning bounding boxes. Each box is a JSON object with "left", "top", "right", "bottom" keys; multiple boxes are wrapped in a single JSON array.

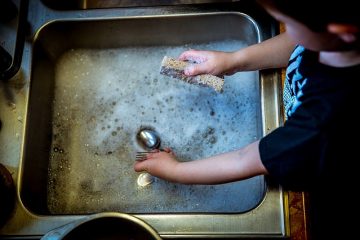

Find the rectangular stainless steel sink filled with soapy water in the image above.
[{"left": 0, "top": 1, "right": 287, "bottom": 238}]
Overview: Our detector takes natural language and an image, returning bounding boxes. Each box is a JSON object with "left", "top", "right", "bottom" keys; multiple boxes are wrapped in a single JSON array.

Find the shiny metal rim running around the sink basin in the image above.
[{"left": 2, "top": 9, "right": 286, "bottom": 240}]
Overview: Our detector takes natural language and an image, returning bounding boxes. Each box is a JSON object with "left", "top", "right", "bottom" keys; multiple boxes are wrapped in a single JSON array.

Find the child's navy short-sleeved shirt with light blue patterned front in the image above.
[{"left": 259, "top": 46, "right": 360, "bottom": 239}]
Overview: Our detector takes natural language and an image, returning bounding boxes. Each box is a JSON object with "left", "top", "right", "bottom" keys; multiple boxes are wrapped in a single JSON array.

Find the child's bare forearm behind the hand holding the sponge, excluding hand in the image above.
[{"left": 233, "top": 32, "right": 295, "bottom": 71}]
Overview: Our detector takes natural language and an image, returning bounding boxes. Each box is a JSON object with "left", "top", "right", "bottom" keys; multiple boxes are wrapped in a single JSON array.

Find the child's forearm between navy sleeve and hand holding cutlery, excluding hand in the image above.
[{"left": 170, "top": 141, "right": 267, "bottom": 184}]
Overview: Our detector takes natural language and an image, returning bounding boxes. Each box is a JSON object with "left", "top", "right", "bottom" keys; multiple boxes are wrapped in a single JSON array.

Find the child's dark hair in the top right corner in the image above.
[{"left": 258, "top": 0, "right": 360, "bottom": 31}]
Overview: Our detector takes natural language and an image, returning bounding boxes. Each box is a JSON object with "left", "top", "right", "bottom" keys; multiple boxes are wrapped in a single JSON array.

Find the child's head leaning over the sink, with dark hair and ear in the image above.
[{"left": 258, "top": 0, "right": 360, "bottom": 51}]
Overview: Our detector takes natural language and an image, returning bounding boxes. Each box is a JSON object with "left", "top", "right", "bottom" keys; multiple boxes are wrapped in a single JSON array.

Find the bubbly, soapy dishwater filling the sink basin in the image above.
[{"left": 48, "top": 40, "right": 264, "bottom": 214}]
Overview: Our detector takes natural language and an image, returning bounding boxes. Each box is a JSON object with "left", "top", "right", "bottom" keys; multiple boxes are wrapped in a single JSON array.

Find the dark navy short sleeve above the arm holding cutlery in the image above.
[{"left": 259, "top": 86, "right": 333, "bottom": 190}]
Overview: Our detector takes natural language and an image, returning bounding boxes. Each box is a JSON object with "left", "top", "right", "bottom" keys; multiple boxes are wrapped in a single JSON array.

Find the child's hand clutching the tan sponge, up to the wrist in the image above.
[{"left": 179, "top": 50, "right": 236, "bottom": 76}]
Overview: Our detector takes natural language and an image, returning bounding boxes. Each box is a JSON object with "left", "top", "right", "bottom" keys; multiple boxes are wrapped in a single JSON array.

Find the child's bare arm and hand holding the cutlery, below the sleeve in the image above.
[{"left": 134, "top": 141, "right": 267, "bottom": 184}]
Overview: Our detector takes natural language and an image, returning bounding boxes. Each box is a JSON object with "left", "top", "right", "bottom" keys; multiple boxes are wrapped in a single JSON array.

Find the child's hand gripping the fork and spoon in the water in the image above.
[{"left": 134, "top": 148, "right": 179, "bottom": 181}]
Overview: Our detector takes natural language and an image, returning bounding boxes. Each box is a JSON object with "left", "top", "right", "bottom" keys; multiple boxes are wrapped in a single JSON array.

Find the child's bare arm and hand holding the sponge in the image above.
[{"left": 179, "top": 32, "right": 295, "bottom": 75}]
